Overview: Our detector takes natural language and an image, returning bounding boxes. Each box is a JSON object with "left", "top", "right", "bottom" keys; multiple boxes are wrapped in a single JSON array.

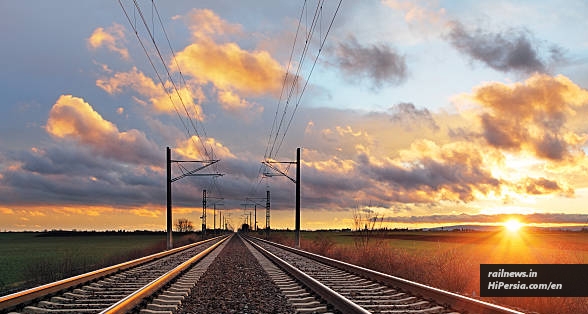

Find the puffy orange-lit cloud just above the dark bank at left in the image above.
[{"left": 46, "top": 95, "right": 160, "bottom": 164}]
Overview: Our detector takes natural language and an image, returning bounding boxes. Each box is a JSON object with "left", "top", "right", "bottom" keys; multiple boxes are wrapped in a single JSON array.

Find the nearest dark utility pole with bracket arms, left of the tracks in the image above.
[{"left": 166, "top": 146, "right": 222, "bottom": 250}]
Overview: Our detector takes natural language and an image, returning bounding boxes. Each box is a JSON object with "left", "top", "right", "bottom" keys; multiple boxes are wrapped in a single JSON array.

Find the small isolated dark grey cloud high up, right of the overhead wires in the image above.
[{"left": 335, "top": 36, "right": 407, "bottom": 89}]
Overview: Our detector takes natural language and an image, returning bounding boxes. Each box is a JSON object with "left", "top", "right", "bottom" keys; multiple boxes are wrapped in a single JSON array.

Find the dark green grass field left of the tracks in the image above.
[{"left": 0, "top": 233, "right": 165, "bottom": 295}]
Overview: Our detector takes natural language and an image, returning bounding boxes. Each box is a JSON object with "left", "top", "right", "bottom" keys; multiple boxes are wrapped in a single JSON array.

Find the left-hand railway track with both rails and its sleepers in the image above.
[{"left": 0, "top": 236, "right": 228, "bottom": 314}]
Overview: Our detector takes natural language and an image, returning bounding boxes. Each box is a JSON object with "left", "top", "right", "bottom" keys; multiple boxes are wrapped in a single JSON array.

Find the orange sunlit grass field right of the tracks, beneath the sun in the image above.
[{"left": 272, "top": 231, "right": 588, "bottom": 314}]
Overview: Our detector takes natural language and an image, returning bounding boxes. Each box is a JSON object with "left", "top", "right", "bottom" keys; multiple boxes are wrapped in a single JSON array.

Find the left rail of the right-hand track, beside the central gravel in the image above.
[{"left": 245, "top": 238, "right": 370, "bottom": 314}]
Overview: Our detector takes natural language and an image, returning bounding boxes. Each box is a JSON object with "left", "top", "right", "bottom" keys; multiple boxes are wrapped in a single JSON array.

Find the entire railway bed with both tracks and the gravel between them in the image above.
[{"left": 0, "top": 235, "right": 521, "bottom": 314}]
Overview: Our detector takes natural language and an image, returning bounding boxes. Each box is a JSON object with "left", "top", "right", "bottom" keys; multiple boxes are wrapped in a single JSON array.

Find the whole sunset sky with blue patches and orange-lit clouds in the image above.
[{"left": 0, "top": 0, "right": 588, "bottom": 231}]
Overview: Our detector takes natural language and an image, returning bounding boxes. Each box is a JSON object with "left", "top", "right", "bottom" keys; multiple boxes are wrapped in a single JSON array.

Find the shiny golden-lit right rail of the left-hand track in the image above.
[{"left": 100, "top": 235, "right": 233, "bottom": 314}]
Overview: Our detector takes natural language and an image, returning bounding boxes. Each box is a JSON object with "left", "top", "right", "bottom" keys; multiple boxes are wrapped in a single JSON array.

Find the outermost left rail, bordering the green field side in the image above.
[{"left": 0, "top": 237, "right": 226, "bottom": 311}]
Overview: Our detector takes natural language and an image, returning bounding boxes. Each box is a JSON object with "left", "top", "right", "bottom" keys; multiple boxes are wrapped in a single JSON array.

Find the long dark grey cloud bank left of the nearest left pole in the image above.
[{"left": 0, "top": 142, "right": 165, "bottom": 207}]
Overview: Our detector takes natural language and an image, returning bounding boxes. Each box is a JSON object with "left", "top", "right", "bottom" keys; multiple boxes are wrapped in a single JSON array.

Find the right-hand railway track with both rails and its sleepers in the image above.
[{"left": 247, "top": 237, "right": 522, "bottom": 314}]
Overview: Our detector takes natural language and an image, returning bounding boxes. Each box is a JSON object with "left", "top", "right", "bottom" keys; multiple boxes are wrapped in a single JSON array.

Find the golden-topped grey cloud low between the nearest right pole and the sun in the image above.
[{"left": 361, "top": 140, "right": 502, "bottom": 202}]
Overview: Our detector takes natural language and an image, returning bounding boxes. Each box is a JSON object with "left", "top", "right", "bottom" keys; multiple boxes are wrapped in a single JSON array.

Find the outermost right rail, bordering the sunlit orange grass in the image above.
[{"left": 248, "top": 238, "right": 525, "bottom": 314}]
